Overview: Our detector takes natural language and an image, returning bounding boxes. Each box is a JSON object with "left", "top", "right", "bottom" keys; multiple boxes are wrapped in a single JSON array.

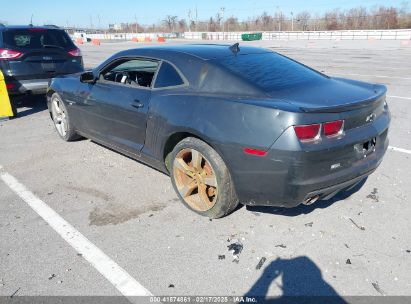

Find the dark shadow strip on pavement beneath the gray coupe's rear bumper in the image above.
[{"left": 247, "top": 178, "right": 367, "bottom": 216}]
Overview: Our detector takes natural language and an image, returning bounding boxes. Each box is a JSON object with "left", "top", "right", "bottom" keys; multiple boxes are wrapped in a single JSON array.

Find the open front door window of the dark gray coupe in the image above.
[{"left": 100, "top": 59, "right": 159, "bottom": 88}]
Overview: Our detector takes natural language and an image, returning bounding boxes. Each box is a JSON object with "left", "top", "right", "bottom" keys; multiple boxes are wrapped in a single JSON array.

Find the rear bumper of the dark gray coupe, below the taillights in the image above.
[{"left": 230, "top": 111, "right": 390, "bottom": 207}]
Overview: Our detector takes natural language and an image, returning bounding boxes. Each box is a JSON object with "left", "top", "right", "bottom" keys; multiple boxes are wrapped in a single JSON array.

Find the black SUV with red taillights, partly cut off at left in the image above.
[{"left": 0, "top": 24, "right": 84, "bottom": 95}]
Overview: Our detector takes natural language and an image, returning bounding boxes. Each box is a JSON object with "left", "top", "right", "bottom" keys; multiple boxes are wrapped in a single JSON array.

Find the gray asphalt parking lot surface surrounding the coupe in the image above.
[{"left": 0, "top": 41, "right": 411, "bottom": 297}]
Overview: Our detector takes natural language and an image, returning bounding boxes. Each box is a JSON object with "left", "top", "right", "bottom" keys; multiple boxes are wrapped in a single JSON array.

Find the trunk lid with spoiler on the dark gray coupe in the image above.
[{"left": 269, "top": 78, "right": 387, "bottom": 112}]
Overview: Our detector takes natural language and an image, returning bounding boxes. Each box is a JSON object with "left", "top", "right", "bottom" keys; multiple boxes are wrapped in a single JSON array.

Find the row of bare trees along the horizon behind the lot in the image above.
[{"left": 104, "top": 2, "right": 411, "bottom": 32}]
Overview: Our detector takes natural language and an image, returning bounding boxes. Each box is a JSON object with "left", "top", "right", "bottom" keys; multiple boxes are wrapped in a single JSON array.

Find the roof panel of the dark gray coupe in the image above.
[{"left": 124, "top": 44, "right": 270, "bottom": 60}]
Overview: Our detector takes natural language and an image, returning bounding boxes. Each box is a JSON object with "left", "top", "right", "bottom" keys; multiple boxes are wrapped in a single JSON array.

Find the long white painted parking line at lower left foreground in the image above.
[{"left": 0, "top": 166, "right": 152, "bottom": 297}]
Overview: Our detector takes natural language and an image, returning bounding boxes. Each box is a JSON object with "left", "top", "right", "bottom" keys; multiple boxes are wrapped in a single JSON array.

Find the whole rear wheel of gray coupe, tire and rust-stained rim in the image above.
[{"left": 171, "top": 137, "right": 238, "bottom": 218}]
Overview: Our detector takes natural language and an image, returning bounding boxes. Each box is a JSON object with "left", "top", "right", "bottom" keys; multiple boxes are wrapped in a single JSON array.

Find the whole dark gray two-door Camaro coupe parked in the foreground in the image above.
[{"left": 47, "top": 44, "right": 390, "bottom": 218}]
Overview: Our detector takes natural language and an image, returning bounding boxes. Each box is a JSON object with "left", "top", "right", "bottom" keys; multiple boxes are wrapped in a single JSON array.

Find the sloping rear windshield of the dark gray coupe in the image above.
[{"left": 217, "top": 52, "right": 325, "bottom": 91}]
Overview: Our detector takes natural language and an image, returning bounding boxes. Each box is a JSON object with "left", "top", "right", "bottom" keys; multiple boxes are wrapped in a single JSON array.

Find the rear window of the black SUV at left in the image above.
[{"left": 3, "top": 28, "right": 73, "bottom": 49}]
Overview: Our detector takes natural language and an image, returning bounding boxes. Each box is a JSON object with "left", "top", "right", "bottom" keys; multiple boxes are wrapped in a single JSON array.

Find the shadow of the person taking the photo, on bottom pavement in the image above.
[{"left": 245, "top": 256, "right": 347, "bottom": 304}]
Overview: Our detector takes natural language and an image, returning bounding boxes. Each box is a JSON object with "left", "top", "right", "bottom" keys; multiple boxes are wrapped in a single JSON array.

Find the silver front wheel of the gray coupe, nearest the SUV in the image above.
[{"left": 50, "top": 93, "right": 80, "bottom": 141}]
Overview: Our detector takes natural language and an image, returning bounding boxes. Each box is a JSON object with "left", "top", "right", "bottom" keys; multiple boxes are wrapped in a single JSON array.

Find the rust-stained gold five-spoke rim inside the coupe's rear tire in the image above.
[{"left": 173, "top": 149, "right": 218, "bottom": 212}]
